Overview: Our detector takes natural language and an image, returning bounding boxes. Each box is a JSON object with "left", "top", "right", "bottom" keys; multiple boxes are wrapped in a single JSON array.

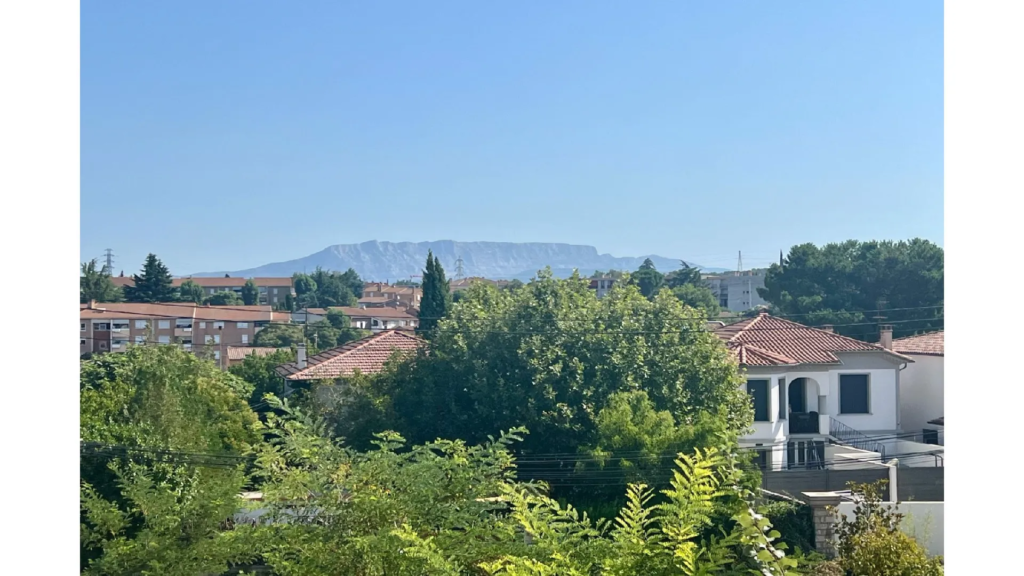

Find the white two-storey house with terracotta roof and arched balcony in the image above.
[{"left": 715, "top": 314, "right": 913, "bottom": 470}]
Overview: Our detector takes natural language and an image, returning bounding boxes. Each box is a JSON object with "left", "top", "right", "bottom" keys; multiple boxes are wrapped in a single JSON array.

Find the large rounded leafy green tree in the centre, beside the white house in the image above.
[{"left": 344, "top": 271, "right": 752, "bottom": 453}]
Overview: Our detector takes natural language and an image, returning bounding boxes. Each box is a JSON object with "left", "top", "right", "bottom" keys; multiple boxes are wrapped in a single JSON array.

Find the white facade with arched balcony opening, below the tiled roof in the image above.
[{"left": 740, "top": 353, "right": 902, "bottom": 470}]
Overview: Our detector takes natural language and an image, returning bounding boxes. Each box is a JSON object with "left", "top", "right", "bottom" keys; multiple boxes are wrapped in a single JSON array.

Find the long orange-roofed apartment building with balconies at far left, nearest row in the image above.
[{"left": 79, "top": 302, "right": 290, "bottom": 367}]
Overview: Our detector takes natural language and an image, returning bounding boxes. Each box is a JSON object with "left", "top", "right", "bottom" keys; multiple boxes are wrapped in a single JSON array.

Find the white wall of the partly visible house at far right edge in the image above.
[{"left": 900, "top": 355, "right": 945, "bottom": 433}]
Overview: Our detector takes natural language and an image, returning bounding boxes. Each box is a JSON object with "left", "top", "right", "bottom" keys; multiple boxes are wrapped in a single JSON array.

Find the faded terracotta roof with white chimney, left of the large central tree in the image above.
[{"left": 278, "top": 330, "right": 426, "bottom": 380}]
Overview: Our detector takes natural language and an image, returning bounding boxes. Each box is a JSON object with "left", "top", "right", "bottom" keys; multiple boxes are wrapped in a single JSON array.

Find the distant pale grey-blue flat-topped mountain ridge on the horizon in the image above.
[{"left": 193, "top": 240, "right": 723, "bottom": 282}]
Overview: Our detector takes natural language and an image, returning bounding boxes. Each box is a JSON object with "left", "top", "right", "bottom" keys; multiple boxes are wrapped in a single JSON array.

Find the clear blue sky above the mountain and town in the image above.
[{"left": 81, "top": 0, "right": 943, "bottom": 274}]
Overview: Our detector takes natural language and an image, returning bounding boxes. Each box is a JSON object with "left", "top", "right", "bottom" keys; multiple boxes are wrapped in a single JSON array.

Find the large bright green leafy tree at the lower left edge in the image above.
[{"left": 80, "top": 346, "right": 260, "bottom": 576}]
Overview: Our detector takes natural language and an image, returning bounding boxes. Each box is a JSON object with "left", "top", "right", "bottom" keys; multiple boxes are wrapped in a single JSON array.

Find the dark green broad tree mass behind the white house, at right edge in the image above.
[{"left": 758, "top": 239, "right": 944, "bottom": 341}]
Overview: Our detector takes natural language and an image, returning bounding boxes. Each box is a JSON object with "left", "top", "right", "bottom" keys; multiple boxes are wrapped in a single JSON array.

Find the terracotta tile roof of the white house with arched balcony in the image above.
[{"left": 715, "top": 313, "right": 912, "bottom": 366}]
